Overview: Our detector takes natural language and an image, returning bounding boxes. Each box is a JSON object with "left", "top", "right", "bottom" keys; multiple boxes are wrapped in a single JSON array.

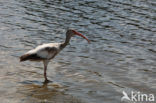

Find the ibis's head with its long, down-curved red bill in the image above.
[{"left": 66, "top": 29, "right": 90, "bottom": 43}]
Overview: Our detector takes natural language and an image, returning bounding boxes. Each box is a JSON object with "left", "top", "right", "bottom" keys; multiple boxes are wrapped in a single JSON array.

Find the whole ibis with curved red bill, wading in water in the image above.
[{"left": 20, "top": 29, "right": 90, "bottom": 82}]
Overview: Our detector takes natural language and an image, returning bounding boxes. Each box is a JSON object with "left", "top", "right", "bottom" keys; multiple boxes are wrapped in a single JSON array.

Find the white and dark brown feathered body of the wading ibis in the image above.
[{"left": 20, "top": 43, "right": 63, "bottom": 61}]
